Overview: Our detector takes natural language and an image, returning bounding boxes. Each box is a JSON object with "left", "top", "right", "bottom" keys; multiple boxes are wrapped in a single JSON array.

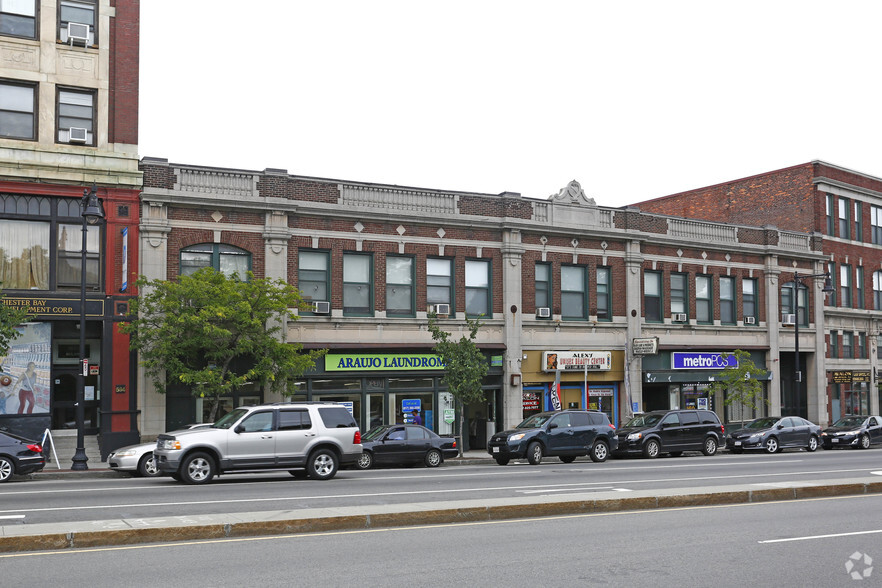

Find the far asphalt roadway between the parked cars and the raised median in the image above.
[{"left": 0, "top": 449, "right": 882, "bottom": 525}]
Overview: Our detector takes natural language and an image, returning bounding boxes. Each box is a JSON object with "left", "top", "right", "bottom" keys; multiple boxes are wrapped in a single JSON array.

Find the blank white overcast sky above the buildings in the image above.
[{"left": 139, "top": 0, "right": 882, "bottom": 206}]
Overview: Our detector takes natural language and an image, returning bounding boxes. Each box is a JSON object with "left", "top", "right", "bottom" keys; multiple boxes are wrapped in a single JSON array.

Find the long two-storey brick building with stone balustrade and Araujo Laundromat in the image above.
[{"left": 139, "top": 158, "right": 824, "bottom": 447}]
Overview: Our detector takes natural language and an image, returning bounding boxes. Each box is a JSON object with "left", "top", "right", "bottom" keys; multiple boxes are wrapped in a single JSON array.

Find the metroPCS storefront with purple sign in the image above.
[{"left": 635, "top": 351, "right": 772, "bottom": 422}]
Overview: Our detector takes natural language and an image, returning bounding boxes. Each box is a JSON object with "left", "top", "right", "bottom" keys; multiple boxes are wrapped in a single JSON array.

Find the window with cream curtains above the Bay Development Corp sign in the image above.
[{"left": 0, "top": 217, "right": 49, "bottom": 290}]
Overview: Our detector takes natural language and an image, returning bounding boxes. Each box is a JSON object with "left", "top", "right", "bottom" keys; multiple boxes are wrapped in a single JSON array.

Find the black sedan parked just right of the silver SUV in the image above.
[{"left": 356, "top": 425, "right": 459, "bottom": 470}]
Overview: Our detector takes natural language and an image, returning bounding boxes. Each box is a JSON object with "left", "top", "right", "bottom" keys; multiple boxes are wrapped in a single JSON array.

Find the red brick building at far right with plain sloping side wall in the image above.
[{"left": 634, "top": 161, "right": 882, "bottom": 420}]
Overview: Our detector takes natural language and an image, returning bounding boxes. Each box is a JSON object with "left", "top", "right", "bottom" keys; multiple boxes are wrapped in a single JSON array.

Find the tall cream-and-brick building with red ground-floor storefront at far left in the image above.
[{"left": 0, "top": 0, "right": 141, "bottom": 462}]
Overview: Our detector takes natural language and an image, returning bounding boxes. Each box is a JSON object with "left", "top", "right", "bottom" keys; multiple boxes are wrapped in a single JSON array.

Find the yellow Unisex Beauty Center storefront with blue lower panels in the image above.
[{"left": 521, "top": 350, "right": 624, "bottom": 426}]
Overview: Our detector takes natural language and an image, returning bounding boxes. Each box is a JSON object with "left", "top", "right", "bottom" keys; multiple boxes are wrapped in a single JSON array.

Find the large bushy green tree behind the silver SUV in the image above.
[{"left": 120, "top": 268, "right": 326, "bottom": 421}]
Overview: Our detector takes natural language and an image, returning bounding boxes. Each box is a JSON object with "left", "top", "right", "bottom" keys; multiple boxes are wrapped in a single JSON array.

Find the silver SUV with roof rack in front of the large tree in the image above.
[{"left": 154, "top": 402, "right": 362, "bottom": 484}]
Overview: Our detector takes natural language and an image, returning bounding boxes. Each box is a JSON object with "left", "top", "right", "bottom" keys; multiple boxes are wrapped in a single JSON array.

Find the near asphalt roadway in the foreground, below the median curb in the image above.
[{"left": 0, "top": 494, "right": 882, "bottom": 588}]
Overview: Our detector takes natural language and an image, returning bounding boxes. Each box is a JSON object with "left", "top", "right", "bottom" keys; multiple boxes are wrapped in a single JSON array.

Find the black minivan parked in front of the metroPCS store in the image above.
[{"left": 615, "top": 410, "right": 726, "bottom": 457}]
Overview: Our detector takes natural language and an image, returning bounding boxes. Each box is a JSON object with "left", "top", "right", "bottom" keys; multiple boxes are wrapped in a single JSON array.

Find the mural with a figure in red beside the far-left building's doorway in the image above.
[{"left": 0, "top": 323, "right": 52, "bottom": 415}]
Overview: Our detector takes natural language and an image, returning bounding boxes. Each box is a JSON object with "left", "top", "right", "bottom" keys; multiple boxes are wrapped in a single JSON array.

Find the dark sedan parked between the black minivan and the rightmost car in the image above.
[{"left": 726, "top": 416, "right": 821, "bottom": 453}]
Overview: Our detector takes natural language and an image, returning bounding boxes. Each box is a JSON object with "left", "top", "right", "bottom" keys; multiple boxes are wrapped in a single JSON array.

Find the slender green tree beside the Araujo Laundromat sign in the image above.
[{"left": 429, "top": 314, "right": 488, "bottom": 457}]
